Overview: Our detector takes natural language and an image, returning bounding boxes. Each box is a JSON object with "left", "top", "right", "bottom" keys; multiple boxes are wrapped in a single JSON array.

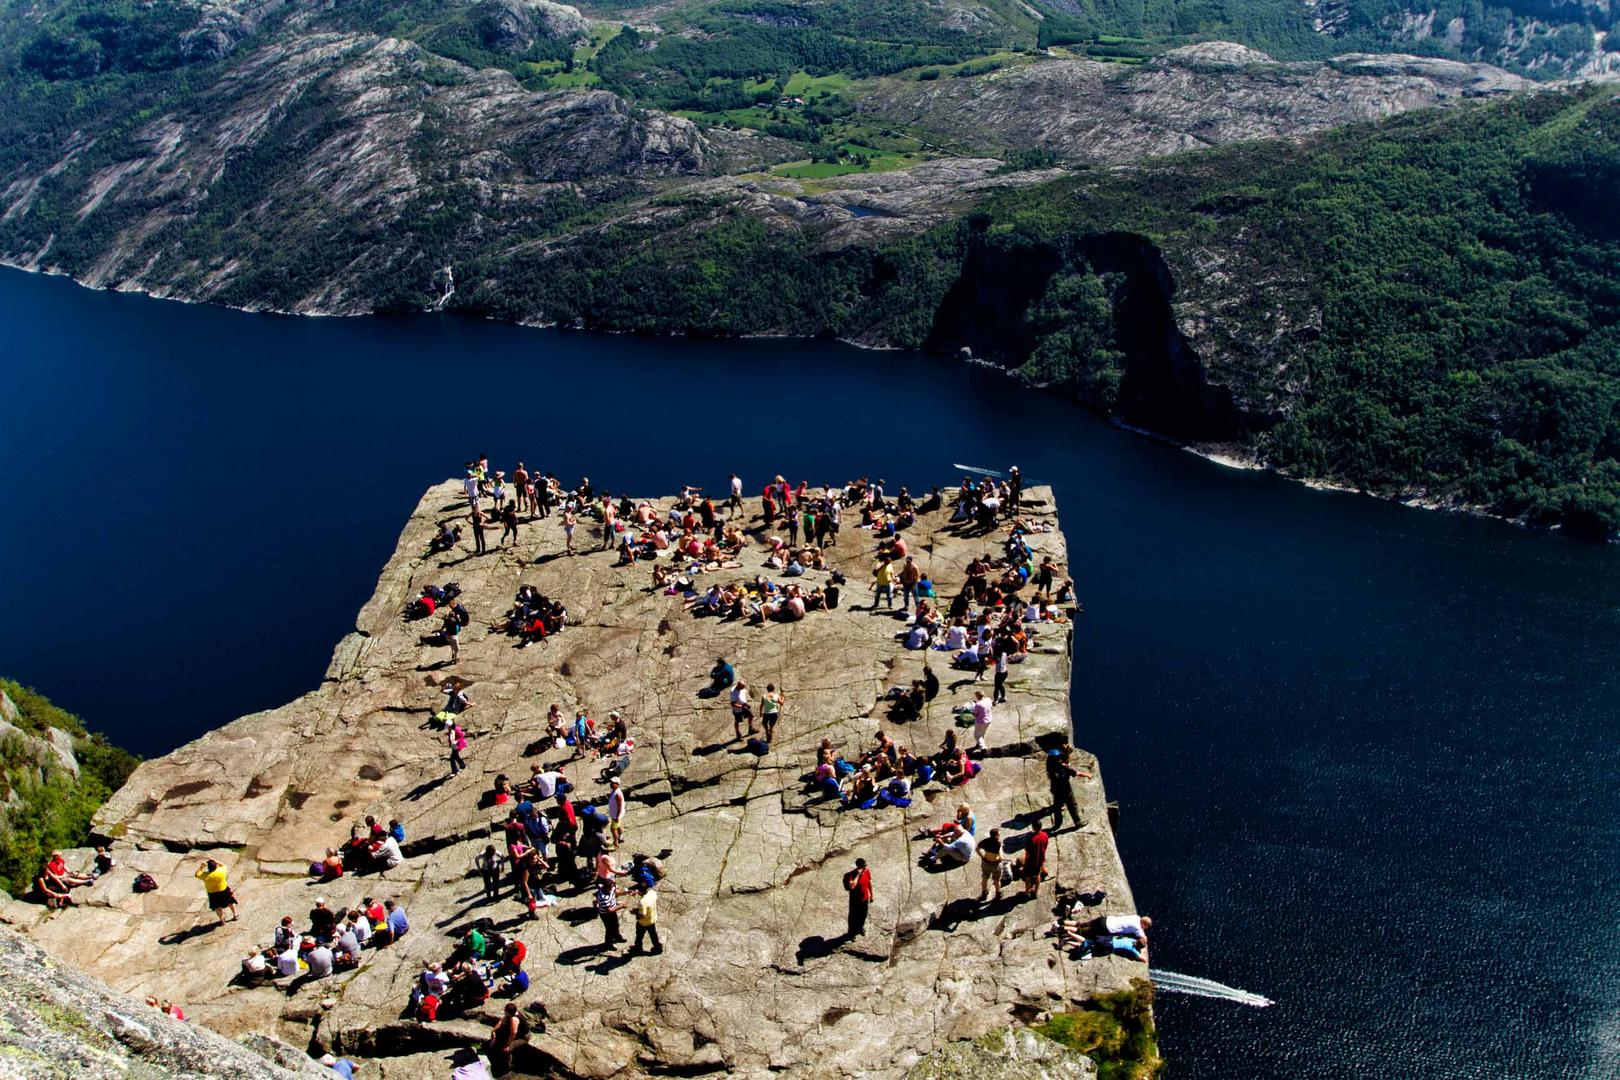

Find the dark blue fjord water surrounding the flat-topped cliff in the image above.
[{"left": 0, "top": 272, "right": 1620, "bottom": 1078}]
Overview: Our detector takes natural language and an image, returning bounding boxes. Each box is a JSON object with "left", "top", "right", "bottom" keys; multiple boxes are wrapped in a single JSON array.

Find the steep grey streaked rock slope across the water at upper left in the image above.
[{"left": 3, "top": 34, "right": 710, "bottom": 313}]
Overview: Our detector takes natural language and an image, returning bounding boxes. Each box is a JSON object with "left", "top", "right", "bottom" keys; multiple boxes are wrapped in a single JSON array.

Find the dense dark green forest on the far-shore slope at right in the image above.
[{"left": 462, "top": 89, "right": 1620, "bottom": 534}]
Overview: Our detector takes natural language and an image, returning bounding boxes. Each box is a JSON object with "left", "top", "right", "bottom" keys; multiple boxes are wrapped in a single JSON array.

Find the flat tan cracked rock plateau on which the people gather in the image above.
[{"left": 19, "top": 484, "right": 1144, "bottom": 1077}]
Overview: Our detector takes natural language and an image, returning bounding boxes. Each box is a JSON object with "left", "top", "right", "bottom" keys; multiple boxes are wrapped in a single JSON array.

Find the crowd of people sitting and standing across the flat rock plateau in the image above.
[{"left": 25, "top": 458, "right": 1150, "bottom": 1075}]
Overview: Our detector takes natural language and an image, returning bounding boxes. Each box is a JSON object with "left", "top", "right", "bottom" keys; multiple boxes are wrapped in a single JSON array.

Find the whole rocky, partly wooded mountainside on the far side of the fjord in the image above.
[{"left": 0, "top": 0, "right": 1620, "bottom": 523}]
